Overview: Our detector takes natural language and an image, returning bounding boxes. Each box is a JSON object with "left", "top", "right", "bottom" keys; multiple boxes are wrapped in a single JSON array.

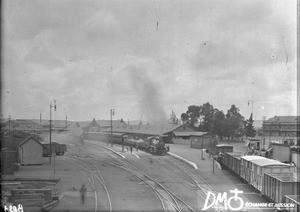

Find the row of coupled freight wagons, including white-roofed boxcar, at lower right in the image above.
[{"left": 219, "top": 152, "right": 300, "bottom": 211}]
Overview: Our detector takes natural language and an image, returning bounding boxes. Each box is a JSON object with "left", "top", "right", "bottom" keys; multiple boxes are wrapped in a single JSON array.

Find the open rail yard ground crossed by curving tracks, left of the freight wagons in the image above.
[{"left": 3, "top": 126, "right": 282, "bottom": 212}]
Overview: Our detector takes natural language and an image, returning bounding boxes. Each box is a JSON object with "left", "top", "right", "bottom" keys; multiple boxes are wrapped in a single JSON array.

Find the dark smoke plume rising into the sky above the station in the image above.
[{"left": 129, "top": 67, "right": 166, "bottom": 122}]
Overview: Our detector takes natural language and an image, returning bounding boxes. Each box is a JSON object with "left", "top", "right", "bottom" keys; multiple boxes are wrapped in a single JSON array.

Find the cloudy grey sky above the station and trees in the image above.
[{"left": 1, "top": 0, "right": 297, "bottom": 120}]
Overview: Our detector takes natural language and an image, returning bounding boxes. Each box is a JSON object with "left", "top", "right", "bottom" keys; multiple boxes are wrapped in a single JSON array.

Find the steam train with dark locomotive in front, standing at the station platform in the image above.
[{"left": 83, "top": 132, "right": 168, "bottom": 155}]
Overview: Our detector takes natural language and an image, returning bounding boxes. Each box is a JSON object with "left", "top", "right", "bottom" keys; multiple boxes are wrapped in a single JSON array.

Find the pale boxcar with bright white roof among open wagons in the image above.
[{"left": 241, "top": 155, "right": 295, "bottom": 192}]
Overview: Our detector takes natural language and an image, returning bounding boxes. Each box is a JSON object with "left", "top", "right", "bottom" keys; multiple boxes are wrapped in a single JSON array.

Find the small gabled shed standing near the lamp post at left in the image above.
[{"left": 18, "top": 137, "right": 43, "bottom": 165}]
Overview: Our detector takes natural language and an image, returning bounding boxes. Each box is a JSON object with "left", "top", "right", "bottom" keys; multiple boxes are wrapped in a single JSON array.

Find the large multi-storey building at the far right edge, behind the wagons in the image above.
[{"left": 262, "top": 116, "right": 300, "bottom": 145}]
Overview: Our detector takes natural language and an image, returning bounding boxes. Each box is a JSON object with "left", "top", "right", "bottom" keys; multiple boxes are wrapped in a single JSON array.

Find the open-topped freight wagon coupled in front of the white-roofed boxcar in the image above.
[{"left": 262, "top": 172, "right": 299, "bottom": 203}]
